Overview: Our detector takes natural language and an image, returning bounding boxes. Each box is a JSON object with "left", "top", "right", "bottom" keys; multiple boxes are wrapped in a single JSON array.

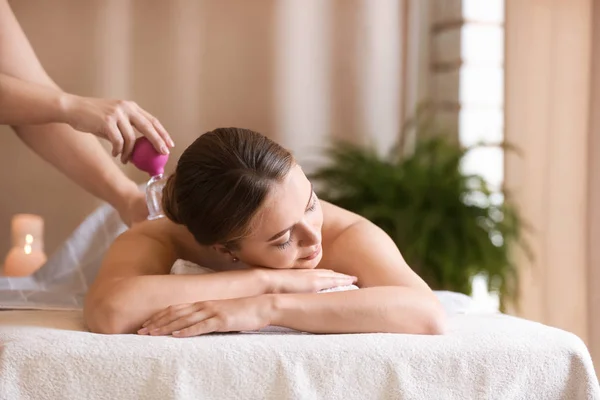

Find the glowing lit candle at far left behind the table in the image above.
[{"left": 4, "top": 214, "right": 46, "bottom": 276}]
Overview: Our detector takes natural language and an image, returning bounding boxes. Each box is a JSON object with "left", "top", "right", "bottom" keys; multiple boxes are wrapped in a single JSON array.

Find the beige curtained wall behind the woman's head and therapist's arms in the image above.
[{"left": 0, "top": 0, "right": 418, "bottom": 257}]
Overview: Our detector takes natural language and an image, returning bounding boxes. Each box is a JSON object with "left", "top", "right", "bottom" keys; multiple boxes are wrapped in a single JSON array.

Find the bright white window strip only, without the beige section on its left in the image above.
[{"left": 458, "top": 0, "right": 504, "bottom": 309}]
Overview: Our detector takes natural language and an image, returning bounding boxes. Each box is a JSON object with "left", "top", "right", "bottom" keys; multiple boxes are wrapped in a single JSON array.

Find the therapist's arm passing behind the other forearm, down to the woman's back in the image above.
[{"left": 0, "top": 0, "right": 162, "bottom": 223}]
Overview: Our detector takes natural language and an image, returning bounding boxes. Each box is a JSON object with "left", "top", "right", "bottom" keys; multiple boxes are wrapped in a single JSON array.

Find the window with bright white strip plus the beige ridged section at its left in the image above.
[{"left": 430, "top": 0, "right": 504, "bottom": 309}]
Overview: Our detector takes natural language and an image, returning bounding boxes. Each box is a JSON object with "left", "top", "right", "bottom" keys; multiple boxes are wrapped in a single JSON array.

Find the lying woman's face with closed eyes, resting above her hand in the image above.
[{"left": 233, "top": 166, "right": 323, "bottom": 269}]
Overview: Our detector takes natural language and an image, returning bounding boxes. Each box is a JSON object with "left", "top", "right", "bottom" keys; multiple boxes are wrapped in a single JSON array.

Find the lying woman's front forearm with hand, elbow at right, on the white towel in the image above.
[{"left": 143, "top": 286, "right": 444, "bottom": 337}]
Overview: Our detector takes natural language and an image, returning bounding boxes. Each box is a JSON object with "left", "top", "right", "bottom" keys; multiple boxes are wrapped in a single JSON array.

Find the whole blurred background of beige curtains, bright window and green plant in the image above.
[{"left": 0, "top": 0, "right": 600, "bottom": 374}]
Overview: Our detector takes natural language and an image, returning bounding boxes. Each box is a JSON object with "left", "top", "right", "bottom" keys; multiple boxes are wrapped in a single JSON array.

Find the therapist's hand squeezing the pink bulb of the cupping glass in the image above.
[{"left": 61, "top": 94, "right": 175, "bottom": 163}]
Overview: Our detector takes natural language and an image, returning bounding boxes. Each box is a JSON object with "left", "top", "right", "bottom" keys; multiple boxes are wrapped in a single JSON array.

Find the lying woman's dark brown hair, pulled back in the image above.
[{"left": 162, "top": 128, "right": 295, "bottom": 247}]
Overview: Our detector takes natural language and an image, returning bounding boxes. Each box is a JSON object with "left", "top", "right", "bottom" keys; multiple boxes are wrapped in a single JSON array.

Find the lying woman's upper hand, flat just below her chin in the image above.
[{"left": 265, "top": 269, "right": 357, "bottom": 293}]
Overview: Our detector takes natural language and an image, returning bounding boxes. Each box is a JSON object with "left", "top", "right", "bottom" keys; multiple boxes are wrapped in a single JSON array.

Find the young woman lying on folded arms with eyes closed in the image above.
[{"left": 84, "top": 128, "right": 445, "bottom": 337}]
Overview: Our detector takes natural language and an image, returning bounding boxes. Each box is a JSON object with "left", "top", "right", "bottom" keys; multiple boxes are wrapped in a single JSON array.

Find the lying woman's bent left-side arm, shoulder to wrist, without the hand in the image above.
[{"left": 84, "top": 219, "right": 267, "bottom": 333}]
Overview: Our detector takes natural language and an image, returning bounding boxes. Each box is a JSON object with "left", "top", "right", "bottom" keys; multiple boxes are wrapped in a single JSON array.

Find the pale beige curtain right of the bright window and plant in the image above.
[{"left": 505, "top": 0, "right": 600, "bottom": 368}]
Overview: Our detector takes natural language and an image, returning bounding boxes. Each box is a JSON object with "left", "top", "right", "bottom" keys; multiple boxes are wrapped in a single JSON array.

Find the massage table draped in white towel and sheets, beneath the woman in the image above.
[{"left": 0, "top": 206, "right": 600, "bottom": 400}]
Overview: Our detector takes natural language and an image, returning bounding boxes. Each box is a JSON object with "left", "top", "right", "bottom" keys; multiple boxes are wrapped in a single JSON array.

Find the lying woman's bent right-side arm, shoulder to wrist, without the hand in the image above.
[{"left": 271, "top": 202, "right": 445, "bottom": 334}]
